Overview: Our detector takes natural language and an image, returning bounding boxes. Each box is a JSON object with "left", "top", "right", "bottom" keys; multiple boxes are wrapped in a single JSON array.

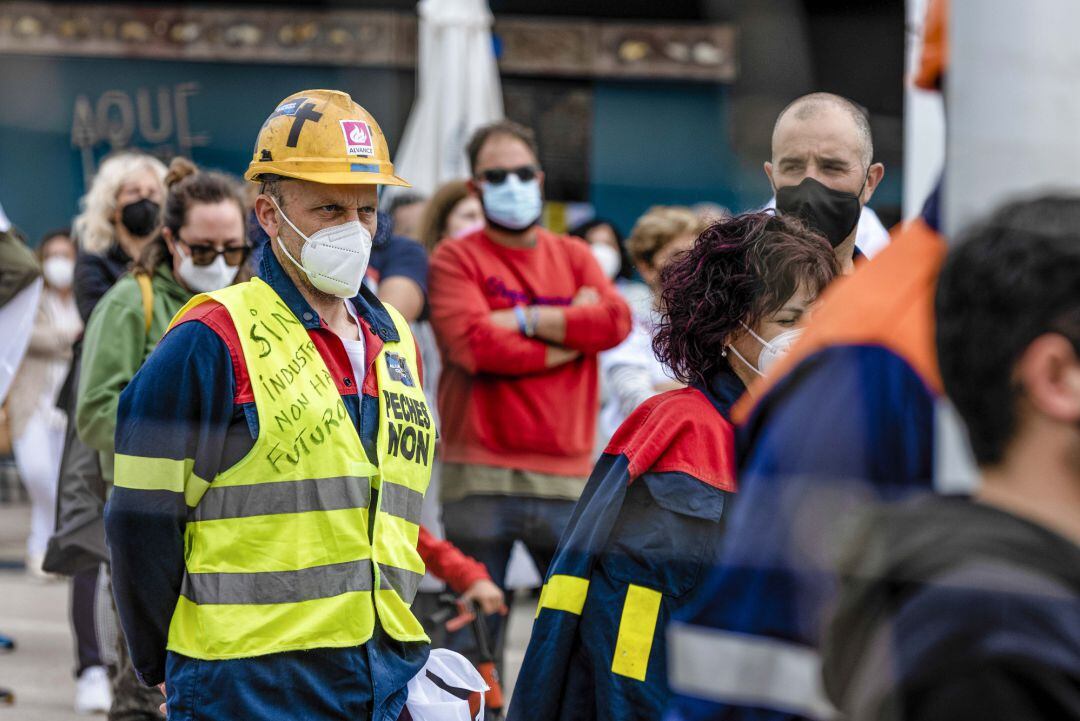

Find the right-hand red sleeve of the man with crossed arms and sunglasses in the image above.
[{"left": 563, "top": 241, "right": 631, "bottom": 354}]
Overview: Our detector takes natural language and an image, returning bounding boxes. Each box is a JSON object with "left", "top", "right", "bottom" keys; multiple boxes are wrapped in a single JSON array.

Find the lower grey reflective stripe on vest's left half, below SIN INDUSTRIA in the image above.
[{"left": 180, "top": 559, "right": 374, "bottom": 604}]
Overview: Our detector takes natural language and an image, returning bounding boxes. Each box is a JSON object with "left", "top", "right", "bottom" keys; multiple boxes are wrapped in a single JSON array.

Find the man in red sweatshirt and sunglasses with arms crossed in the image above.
[{"left": 430, "top": 121, "right": 630, "bottom": 669}]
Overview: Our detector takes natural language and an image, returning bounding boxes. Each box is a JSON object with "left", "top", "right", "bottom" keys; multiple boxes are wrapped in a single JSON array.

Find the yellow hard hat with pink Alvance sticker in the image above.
[{"left": 244, "top": 90, "right": 409, "bottom": 188}]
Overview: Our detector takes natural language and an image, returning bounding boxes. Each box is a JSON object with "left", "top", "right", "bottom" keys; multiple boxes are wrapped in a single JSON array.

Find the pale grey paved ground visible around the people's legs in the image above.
[{"left": 0, "top": 504, "right": 536, "bottom": 721}]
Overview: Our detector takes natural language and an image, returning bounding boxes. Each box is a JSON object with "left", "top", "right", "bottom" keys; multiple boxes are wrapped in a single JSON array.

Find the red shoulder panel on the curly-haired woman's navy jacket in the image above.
[{"left": 604, "top": 389, "right": 735, "bottom": 491}]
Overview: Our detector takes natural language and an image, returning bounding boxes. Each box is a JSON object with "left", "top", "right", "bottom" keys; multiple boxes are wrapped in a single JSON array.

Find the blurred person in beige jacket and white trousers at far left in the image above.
[{"left": 10, "top": 230, "right": 82, "bottom": 577}]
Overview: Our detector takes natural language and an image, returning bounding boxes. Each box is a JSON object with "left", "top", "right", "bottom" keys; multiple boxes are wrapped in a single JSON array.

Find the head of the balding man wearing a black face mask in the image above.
[{"left": 765, "top": 93, "right": 885, "bottom": 273}]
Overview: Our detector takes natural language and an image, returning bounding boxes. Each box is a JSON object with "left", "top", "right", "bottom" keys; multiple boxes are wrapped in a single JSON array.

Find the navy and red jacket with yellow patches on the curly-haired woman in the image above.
[{"left": 510, "top": 372, "right": 743, "bottom": 721}]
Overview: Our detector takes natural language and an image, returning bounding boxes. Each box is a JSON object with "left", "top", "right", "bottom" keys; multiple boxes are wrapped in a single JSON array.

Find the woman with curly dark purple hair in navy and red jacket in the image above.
[{"left": 510, "top": 213, "right": 839, "bottom": 721}]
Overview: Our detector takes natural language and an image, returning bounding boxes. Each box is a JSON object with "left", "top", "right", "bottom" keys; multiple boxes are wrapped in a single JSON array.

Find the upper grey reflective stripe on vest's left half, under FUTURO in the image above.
[{"left": 191, "top": 476, "right": 372, "bottom": 520}]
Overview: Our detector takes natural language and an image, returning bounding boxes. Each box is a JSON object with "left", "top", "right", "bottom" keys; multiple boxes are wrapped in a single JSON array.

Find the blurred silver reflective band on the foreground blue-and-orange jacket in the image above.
[{"left": 667, "top": 623, "right": 837, "bottom": 719}]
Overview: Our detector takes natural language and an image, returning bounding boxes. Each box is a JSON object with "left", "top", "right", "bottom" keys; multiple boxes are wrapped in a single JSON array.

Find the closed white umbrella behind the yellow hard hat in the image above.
[{"left": 386, "top": 0, "right": 502, "bottom": 198}]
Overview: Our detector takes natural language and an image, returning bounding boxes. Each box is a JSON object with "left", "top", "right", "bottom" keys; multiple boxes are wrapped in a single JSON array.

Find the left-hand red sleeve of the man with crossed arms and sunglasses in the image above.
[{"left": 430, "top": 244, "right": 548, "bottom": 376}]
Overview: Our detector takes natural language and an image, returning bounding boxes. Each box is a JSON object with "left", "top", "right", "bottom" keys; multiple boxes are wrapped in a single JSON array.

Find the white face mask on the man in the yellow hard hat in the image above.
[{"left": 270, "top": 196, "right": 372, "bottom": 298}]
